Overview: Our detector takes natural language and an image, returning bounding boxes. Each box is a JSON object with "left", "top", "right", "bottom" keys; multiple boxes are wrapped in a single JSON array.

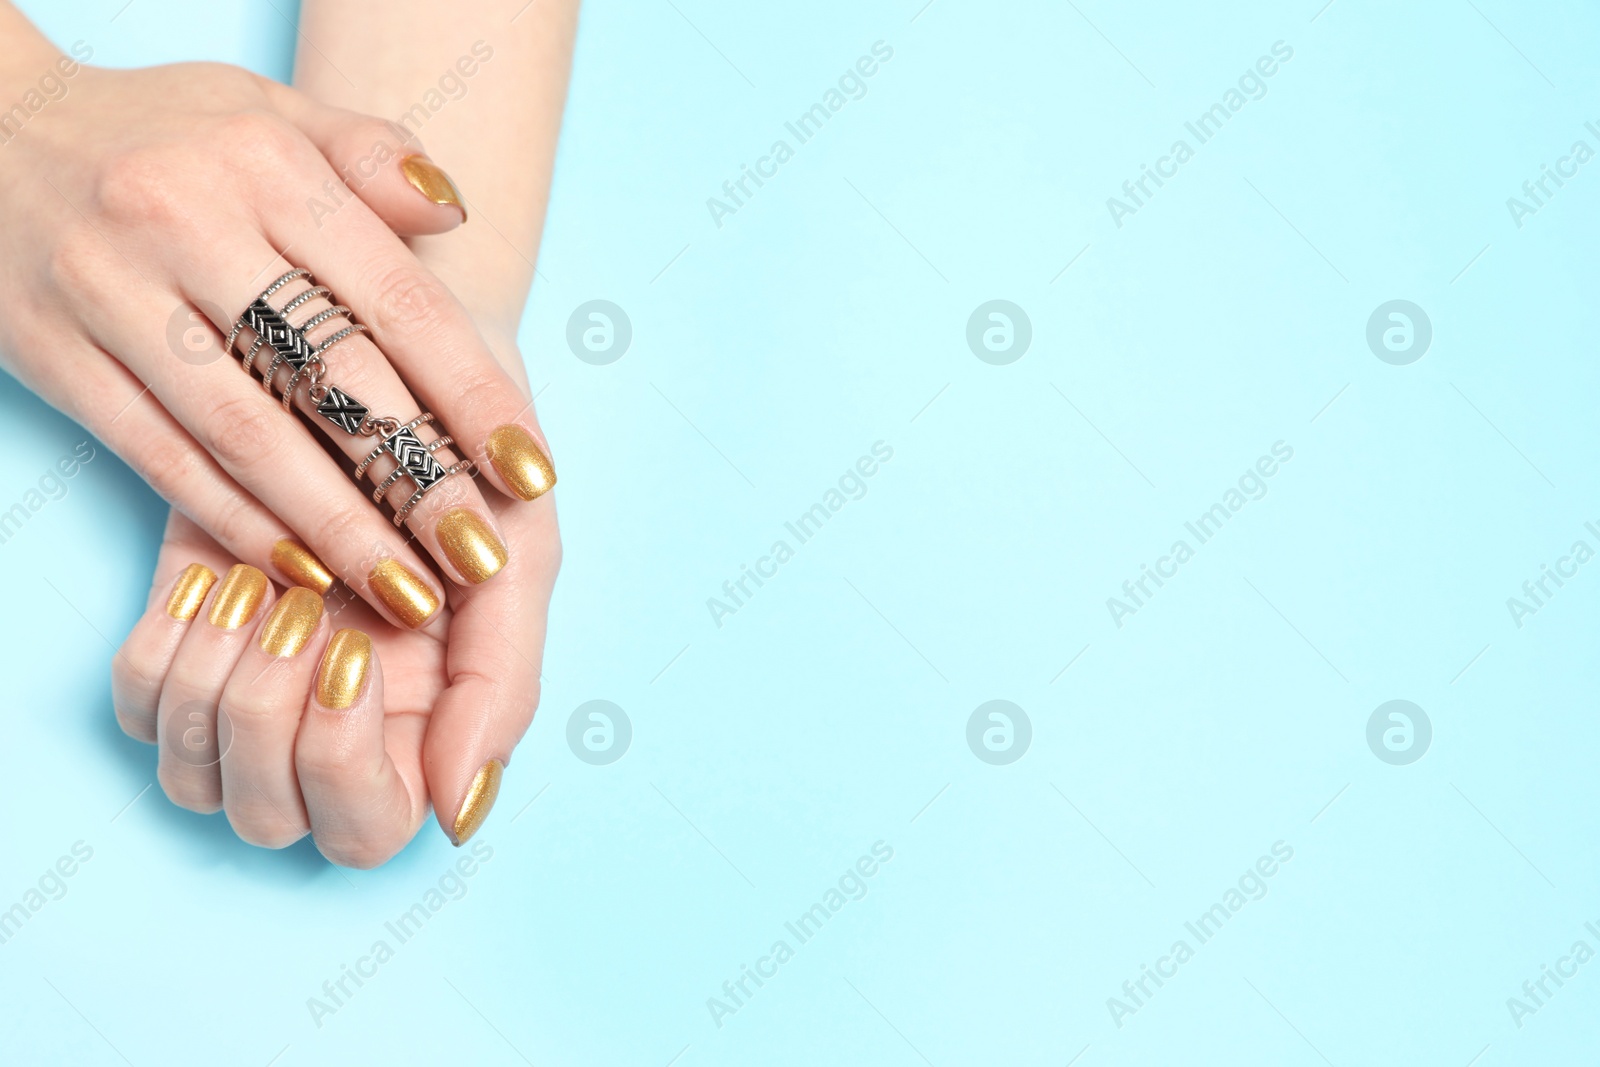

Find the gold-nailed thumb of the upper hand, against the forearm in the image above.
[{"left": 266, "top": 82, "right": 467, "bottom": 237}]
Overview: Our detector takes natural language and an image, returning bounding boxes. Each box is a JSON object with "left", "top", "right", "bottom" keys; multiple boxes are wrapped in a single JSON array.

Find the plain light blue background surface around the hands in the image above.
[{"left": 0, "top": 0, "right": 1600, "bottom": 1067}]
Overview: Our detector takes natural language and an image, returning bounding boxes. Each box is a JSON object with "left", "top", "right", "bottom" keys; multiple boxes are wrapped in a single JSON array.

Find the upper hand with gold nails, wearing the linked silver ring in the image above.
[{"left": 0, "top": 35, "right": 555, "bottom": 627}]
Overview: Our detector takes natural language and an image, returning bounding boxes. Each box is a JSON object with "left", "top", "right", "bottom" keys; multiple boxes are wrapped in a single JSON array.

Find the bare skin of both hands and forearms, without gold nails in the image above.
[{"left": 0, "top": 0, "right": 576, "bottom": 867}]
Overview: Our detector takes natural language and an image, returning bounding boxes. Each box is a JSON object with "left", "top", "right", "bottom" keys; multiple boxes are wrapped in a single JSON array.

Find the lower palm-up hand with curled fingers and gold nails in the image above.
[{"left": 112, "top": 489, "right": 557, "bottom": 867}]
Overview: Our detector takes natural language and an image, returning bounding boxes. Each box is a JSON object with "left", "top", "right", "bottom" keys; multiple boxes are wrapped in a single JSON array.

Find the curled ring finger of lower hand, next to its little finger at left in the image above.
[{"left": 155, "top": 563, "right": 274, "bottom": 813}]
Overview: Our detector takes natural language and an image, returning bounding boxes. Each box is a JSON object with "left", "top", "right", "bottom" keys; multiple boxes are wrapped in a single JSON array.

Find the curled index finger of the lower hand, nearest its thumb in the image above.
[{"left": 294, "top": 630, "right": 427, "bottom": 869}]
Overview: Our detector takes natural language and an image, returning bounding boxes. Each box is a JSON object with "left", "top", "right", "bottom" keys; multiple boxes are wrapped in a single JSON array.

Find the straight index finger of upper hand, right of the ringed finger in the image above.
[{"left": 266, "top": 158, "right": 555, "bottom": 501}]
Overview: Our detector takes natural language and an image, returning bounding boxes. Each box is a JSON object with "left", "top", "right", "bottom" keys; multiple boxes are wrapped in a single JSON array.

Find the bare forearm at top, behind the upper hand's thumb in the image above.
[{"left": 294, "top": 0, "right": 578, "bottom": 347}]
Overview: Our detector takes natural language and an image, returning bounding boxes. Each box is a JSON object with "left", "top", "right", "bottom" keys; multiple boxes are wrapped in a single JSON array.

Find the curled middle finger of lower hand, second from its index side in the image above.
[{"left": 219, "top": 589, "right": 331, "bottom": 848}]
